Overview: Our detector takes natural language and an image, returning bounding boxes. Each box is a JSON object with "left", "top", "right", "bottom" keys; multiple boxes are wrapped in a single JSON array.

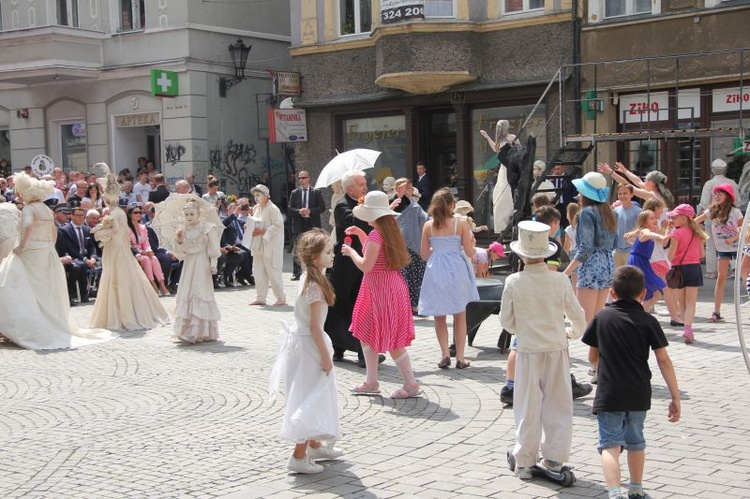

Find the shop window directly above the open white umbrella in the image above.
[{"left": 341, "top": 115, "right": 411, "bottom": 186}]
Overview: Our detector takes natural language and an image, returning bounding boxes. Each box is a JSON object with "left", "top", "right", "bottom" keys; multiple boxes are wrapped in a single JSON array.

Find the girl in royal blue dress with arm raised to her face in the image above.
[{"left": 624, "top": 210, "right": 667, "bottom": 310}]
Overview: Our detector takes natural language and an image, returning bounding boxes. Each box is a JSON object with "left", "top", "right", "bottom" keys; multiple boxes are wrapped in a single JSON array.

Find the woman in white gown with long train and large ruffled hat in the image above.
[{"left": 0, "top": 173, "right": 117, "bottom": 350}]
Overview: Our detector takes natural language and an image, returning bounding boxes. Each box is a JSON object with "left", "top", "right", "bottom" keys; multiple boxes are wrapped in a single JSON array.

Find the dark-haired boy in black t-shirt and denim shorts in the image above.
[{"left": 582, "top": 265, "right": 680, "bottom": 499}]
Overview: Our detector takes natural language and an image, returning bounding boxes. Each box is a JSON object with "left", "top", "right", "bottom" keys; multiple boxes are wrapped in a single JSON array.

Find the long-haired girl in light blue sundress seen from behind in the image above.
[{"left": 418, "top": 188, "right": 479, "bottom": 369}]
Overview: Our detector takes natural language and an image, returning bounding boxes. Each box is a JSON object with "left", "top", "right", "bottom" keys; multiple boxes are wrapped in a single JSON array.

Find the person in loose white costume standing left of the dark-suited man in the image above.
[{"left": 250, "top": 184, "right": 286, "bottom": 306}]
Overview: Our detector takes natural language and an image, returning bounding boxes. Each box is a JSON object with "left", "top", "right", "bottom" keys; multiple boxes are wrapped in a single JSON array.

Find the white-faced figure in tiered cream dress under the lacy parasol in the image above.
[{"left": 174, "top": 199, "right": 221, "bottom": 343}]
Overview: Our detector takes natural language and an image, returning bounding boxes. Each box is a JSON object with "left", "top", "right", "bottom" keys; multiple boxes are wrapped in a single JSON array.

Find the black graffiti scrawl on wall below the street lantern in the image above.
[{"left": 208, "top": 139, "right": 261, "bottom": 193}]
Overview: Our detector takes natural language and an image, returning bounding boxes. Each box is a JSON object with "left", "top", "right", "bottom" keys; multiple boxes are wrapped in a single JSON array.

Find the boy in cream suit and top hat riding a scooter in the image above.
[{"left": 500, "top": 221, "right": 586, "bottom": 480}]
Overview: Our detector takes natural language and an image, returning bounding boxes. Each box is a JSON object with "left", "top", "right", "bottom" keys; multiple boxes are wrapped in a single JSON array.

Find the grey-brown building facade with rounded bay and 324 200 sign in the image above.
[{"left": 291, "top": 0, "right": 576, "bottom": 224}]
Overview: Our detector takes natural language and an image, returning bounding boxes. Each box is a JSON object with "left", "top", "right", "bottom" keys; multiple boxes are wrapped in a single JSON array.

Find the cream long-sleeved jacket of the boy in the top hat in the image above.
[{"left": 500, "top": 263, "right": 586, "bottom": 353}]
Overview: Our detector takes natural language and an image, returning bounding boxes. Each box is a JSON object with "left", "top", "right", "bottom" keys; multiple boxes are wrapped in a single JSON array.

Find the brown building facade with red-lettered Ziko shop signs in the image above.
[{"left": 581, "top": 0, "right": 750, "bottom": 203}]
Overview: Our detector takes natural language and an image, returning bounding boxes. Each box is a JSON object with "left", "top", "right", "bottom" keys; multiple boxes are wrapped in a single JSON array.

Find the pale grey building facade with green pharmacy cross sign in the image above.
[{"left": 0, "top": 0, "right": 291, "bottom": 199}]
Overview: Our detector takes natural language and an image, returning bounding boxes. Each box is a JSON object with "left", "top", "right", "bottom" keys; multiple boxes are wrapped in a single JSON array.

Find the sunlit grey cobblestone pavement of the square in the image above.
[{"left": 0, "top": 264, "right": 750, "bottom": 499}]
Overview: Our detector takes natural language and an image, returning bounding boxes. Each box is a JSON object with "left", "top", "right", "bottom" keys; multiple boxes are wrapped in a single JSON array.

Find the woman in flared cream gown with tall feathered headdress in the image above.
[{"left": 91, "top": 163, "right": 169, "bottom": 330}]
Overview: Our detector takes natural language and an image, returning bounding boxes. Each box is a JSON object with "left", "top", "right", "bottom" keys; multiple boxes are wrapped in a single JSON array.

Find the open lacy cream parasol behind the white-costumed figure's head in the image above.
[{"left": 151, "top": 192, "right": 224, "bottom": 260}]
